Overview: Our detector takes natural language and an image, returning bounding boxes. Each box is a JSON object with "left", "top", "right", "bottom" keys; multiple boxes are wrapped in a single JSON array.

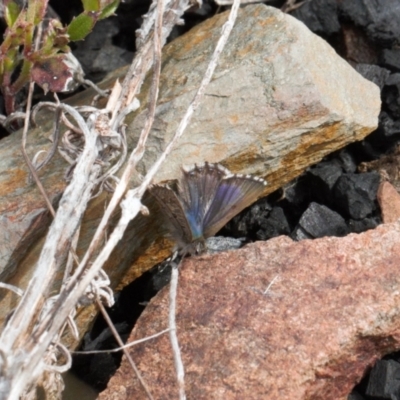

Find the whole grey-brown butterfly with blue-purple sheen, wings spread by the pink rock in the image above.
[{"left": 149, "top": 162, "right": 267, "bottom": 254}]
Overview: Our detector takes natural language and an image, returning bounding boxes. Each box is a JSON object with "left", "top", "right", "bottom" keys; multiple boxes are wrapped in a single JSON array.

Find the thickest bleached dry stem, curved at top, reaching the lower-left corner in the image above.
[{"left": 0, "top": 105, "right": 100, "bottom": 398}]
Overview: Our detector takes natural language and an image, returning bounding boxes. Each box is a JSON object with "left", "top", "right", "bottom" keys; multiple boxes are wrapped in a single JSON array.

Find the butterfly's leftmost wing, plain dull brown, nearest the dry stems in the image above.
[{"left": 149, "top": 185, "right": 193, "bottom": 247}]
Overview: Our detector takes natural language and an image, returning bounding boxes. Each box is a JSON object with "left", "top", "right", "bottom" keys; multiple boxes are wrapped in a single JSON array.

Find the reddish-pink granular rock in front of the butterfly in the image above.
[{"left": 99, "top": 223, "right": 400, "bottom": 400}]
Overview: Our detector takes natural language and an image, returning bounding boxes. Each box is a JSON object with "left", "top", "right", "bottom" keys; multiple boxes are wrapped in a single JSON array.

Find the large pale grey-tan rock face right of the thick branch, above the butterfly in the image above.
[{"left": 129, "top": 5, "right": 380, "bottom": 184}]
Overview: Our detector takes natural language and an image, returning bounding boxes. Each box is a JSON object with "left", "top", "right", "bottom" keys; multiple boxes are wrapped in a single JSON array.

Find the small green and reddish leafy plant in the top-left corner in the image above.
[{"left": 0, "top": 0, "right": 120, "bottom": 114}]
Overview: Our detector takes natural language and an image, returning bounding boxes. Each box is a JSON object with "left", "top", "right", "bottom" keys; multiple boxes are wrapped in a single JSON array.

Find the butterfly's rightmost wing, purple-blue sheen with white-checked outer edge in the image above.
[{"left": 204, "top": 175, "right": 267, "bottom": 238}]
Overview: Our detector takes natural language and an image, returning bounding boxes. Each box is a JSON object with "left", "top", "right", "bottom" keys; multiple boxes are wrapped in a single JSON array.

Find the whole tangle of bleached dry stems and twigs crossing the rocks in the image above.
[{"left": 0, "top": 0, "right": 240, "bottom": 400}]
